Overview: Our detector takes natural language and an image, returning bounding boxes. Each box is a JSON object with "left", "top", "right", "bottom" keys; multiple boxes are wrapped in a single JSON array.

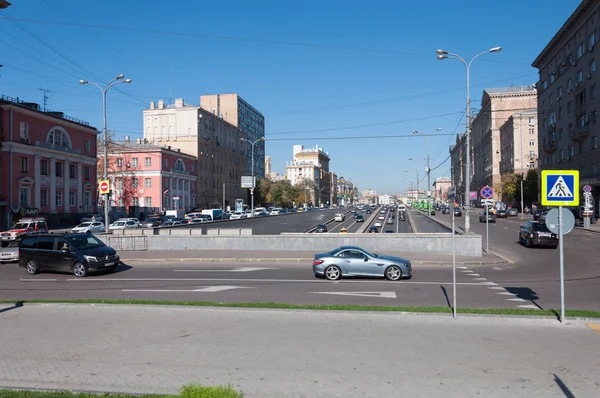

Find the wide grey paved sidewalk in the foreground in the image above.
[{"left": 0, "top": 304, "right": 600, "bottom": 398}]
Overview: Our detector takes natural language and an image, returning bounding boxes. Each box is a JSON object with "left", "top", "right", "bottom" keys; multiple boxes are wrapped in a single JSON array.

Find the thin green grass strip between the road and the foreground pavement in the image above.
[{"left": 0, "top": 299, "right": 600, "bottom": 318}]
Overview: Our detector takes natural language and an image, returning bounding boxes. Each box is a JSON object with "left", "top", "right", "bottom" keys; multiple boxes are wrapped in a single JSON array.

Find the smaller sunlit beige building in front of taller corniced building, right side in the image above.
[{"left": 500, "top": 110, "right": 538, "bottom": 176}]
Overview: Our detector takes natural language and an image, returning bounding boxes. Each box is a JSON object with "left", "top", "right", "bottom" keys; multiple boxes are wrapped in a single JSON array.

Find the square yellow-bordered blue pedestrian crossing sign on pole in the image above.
[{"left": 542, "top": 170, "right": 579, "bottom": 206}]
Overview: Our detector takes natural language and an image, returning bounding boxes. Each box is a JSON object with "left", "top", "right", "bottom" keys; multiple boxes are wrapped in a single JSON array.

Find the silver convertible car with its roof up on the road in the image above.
[{"left": 313, "top": 246, "right": 412, "bottom": 281}]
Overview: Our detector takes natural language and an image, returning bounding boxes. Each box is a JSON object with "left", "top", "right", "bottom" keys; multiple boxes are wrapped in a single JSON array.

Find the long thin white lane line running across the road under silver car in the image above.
[{"left": 66, "top": 278, "right": 495, "bottom": 286}]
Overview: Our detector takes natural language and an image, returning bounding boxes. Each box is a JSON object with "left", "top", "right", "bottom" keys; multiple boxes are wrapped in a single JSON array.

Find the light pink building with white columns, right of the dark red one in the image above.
[{"left": 103, "top": 142, "right": 198, "bottom": 215}]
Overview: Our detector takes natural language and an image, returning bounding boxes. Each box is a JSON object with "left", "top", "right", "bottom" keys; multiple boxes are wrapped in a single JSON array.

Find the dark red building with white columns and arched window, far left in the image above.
[{"left": 0, "top": 96, "right": 98, "bottom": 229}]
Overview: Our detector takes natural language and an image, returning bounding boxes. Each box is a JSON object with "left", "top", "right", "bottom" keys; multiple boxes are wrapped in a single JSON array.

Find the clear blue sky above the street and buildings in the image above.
[{"left": 0, "top": 0, "right": 580, "bottom": 193}]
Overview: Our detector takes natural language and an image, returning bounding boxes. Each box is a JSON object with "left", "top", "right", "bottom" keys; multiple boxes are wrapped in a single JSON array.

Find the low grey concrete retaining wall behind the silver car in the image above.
[{"left": 98, "top": 235, "right": 482, "bottom": 256}]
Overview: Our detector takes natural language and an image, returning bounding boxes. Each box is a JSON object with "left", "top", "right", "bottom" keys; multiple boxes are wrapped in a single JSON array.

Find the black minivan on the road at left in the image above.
[{"left": 19, "top": 233, "right": 120, "bottom": 277}]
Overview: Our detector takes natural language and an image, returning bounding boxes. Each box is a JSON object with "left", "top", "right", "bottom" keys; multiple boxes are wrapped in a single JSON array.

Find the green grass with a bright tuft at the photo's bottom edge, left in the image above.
[{"left": 0, "top": 384, "right": 243, "bottom": 398}]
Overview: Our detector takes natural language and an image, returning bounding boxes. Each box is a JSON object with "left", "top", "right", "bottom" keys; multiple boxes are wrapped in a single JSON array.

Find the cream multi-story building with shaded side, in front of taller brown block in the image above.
[{"left": 144, "top": 99, "right": 248, "bottom": 208}]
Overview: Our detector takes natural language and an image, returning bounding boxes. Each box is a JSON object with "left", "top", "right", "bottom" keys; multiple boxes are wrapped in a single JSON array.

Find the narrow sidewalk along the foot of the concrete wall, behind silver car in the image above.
[{"left": 119, "top": 250, "right": 508, "bottom": 266}]
